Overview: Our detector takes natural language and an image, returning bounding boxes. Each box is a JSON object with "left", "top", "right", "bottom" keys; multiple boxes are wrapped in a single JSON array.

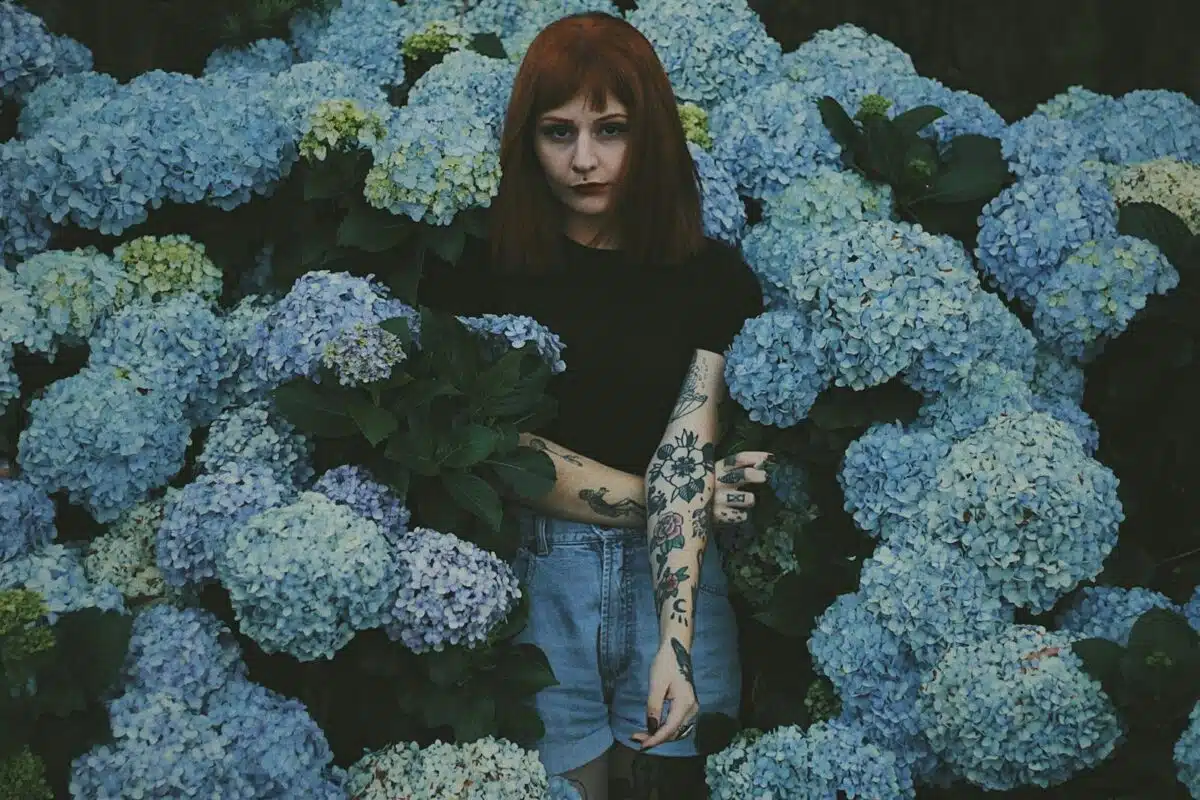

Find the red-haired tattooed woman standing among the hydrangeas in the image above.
[{"left": 421, "top": 13, "right": 767, "bottom": 800}]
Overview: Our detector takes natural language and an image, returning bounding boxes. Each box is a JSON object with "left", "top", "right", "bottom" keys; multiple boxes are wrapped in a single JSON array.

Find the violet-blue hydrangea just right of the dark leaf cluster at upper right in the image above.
[{"left": 976, "top": 173, "right": 1117, "bottom": 306}]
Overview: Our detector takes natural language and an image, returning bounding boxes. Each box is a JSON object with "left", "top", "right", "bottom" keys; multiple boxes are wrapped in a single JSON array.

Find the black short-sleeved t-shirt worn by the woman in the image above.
[{"left": 418, "top": 236, "right": 762, "bottom": 475}]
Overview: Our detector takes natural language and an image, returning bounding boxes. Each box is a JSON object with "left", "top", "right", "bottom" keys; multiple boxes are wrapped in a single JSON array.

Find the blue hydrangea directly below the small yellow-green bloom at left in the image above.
[{"left": 88, "top": 293, "right": 228, "bottom": 425}]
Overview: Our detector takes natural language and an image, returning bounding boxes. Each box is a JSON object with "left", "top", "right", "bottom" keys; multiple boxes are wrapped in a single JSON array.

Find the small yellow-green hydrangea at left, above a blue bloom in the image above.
[{"left": 113, "top": 234, "right": 223, "bottom": 302}]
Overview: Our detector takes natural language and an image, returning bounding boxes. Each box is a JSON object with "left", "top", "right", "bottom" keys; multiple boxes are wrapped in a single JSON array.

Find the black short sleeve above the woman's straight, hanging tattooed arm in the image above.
[{"left": 695, "top": 240, "right": 763, "bottom": 354}]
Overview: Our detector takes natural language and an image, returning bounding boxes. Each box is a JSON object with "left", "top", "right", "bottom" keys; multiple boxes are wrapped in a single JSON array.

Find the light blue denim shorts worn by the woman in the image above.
[{"left": 514, "top": 509, "right": 742, "bottom": 775}]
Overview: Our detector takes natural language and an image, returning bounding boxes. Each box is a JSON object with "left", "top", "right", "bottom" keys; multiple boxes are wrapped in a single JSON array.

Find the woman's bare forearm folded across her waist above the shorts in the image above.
[{"left": 521, "top": 433, "right": 646, "bottom": 528}]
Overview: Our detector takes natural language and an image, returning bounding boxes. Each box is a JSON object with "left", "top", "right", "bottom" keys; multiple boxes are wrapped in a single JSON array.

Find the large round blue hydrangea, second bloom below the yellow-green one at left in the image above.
[{"left": 17, "top": 368, "right": 191, "bottom": 522}]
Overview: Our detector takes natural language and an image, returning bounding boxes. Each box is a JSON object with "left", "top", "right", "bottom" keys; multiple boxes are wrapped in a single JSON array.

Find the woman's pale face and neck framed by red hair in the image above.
[{"left": 534, "top": 95, "right": 629, "bottom": 243}]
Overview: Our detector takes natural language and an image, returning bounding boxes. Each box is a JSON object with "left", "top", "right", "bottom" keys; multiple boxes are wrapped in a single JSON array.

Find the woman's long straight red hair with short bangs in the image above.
[{"left": 488, "top": 12, "right": 704, "bottom": 272}]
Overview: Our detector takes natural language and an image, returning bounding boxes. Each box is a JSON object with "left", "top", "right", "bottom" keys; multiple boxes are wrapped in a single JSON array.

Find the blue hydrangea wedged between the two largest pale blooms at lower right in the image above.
[{"left": 858, "top": 537, "right": 1013, "bottom": 668}]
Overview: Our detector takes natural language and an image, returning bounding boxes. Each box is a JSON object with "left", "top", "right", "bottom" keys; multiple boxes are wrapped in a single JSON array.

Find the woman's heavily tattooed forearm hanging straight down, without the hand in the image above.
[{"left": 646, "top": 350, "right": 725, "bottom": 650}]
